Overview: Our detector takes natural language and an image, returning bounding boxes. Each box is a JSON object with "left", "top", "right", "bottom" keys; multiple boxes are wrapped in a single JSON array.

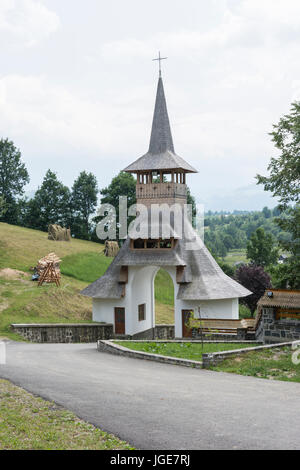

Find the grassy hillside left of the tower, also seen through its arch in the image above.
[{"left": 0, "top": 223, "right": 174, "bottom": 339}]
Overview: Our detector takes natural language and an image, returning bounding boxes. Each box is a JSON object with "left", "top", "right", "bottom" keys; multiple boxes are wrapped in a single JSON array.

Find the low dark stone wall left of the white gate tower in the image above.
[{"left": 11, "top": 323, "right": 113, "bottom": 343}]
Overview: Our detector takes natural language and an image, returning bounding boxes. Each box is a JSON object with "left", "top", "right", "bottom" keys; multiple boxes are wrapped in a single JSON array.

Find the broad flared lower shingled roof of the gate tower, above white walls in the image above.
[{"left": 81, "top": 218, "right": 251, "bottom": 300}]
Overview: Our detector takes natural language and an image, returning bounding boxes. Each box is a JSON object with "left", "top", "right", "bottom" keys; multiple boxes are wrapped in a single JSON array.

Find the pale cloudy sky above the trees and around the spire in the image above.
[{"left": 0, "top": 0, "right": 300, "bottom": 211}]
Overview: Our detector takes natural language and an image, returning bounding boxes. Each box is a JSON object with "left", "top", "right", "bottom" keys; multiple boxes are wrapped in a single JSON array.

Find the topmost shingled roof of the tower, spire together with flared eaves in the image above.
[{"left": 124, "top": 77, "right": 197, "bottom": 173}]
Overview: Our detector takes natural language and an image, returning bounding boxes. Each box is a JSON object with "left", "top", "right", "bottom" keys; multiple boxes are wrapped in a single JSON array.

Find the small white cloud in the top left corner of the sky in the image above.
[{"left": 0, "top": 0, "right": 60, "bottom": 47}]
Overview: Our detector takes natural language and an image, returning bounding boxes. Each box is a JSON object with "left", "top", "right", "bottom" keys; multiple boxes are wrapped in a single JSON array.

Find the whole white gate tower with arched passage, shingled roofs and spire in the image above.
[{"left": 81, "top": 70, "right": 251, "bottom": 338}]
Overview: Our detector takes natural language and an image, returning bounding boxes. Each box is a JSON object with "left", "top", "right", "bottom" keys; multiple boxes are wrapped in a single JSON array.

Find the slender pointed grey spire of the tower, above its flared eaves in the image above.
[{"left": 149, "top": 76, "right": 174, "bottom": 155}]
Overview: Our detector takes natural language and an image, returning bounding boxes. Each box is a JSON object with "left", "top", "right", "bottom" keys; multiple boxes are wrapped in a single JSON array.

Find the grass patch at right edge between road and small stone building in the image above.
[{"left": 211, "top": 348, "right": 300, "bottom": 382}]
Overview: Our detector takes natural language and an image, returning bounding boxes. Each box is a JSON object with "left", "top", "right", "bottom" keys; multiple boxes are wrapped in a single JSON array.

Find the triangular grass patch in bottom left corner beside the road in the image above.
[{"left": 0, "top": 380, "right": 132, "bottom": 450}]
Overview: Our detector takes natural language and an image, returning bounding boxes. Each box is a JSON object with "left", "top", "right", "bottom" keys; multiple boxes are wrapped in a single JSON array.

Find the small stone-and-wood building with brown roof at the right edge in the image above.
[{"left": 257, "top": 289, "right": 300, "bottom": 343}]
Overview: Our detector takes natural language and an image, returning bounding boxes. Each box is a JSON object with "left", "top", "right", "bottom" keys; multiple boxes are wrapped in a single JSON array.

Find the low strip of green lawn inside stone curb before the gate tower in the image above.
[{"left": 116, "top": 341, "right": 257, "bottom": 361}]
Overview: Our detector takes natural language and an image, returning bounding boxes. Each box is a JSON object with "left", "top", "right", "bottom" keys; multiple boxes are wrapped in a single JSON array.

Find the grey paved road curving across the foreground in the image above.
[{"left": 0, "top": 342, "right": 300, "bottom": 450}]
